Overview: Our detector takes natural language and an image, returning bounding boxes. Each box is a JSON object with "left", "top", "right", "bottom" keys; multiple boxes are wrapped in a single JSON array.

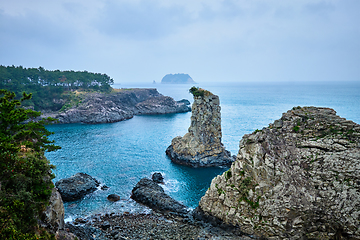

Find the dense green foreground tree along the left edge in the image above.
[{"left": 0, "top": 89, "right": 60, "bottom": 239}]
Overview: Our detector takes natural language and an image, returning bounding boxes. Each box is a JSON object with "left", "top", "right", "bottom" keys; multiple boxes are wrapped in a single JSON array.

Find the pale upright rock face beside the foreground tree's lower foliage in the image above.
[{"left": 40, "top": 188, "right": 65, "bottom": 234}]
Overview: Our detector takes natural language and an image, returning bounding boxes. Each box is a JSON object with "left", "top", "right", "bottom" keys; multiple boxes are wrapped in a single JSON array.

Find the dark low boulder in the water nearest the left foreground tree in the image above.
[{"left": 55, "top": 173, "right": 100, "bottom": 202}]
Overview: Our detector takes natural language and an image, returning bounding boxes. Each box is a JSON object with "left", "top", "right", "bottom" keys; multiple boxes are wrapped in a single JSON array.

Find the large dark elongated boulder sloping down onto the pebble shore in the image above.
[{"left": 131, "top": 178, "right": 188, "bottom": 215}]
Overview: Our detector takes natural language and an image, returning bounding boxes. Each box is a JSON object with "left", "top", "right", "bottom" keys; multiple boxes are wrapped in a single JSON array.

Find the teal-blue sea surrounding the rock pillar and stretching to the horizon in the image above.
[{"left": 46, "top": 82, "right": 360, "bottom": 221}]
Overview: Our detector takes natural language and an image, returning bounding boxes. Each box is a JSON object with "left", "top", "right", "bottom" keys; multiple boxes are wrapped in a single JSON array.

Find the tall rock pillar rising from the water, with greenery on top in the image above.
[{"left": 166, "top": 87, "right": 235, "bottom": 167}]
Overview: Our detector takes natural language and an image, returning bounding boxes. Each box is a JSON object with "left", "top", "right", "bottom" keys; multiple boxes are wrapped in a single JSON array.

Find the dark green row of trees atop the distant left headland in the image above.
[{"left": 0, "top": 65, "right": 114, "bottom": 111}]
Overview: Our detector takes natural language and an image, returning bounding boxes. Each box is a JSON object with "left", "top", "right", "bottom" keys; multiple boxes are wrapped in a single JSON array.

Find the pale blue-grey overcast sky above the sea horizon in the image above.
[{"left": 0, "top": 0, "right": 360, "bottom": 83}]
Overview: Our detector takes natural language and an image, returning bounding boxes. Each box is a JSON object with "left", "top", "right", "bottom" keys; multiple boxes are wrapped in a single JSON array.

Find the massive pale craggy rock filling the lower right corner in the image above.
[{"left": 198, "top": 107, "right": 360, "bottom": 239}]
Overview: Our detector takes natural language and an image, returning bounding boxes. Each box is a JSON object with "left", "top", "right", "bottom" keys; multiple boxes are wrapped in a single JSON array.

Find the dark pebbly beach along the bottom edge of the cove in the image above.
[{"left": 65, "top": 211, "right": 259, "bottom": 240}]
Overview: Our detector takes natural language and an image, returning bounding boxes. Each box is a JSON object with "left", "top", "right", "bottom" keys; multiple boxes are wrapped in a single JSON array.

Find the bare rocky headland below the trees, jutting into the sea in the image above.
[{"left": 43, "top": 89, "right": 191, "bottom": 123}]
